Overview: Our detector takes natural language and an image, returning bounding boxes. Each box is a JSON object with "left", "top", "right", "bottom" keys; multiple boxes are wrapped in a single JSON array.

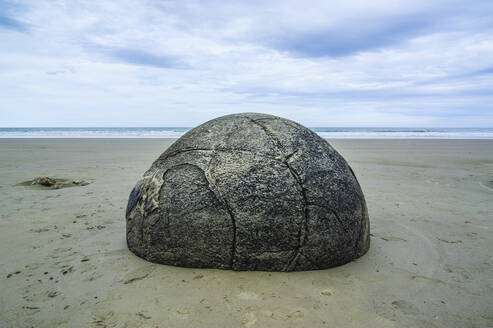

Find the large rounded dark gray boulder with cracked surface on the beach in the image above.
[{"left": 126, "top": 113, "right": 370, "bottom": 271}]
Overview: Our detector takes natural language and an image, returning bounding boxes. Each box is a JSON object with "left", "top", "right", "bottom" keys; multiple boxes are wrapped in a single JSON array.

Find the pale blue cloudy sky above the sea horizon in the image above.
[{"left": 0, "top": 0, "right": 493, "bottom": 127}]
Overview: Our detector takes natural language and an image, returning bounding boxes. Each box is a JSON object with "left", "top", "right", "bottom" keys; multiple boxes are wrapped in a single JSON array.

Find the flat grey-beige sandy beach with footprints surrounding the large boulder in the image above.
[{"left": 0, "top": 139, "right": 493, "bottom": 327}]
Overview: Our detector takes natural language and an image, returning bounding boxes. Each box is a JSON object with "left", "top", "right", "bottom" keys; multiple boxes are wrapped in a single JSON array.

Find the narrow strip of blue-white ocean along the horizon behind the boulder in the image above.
[{"left": 0, "top": 127, "right": 493, "bottom": 139}]
